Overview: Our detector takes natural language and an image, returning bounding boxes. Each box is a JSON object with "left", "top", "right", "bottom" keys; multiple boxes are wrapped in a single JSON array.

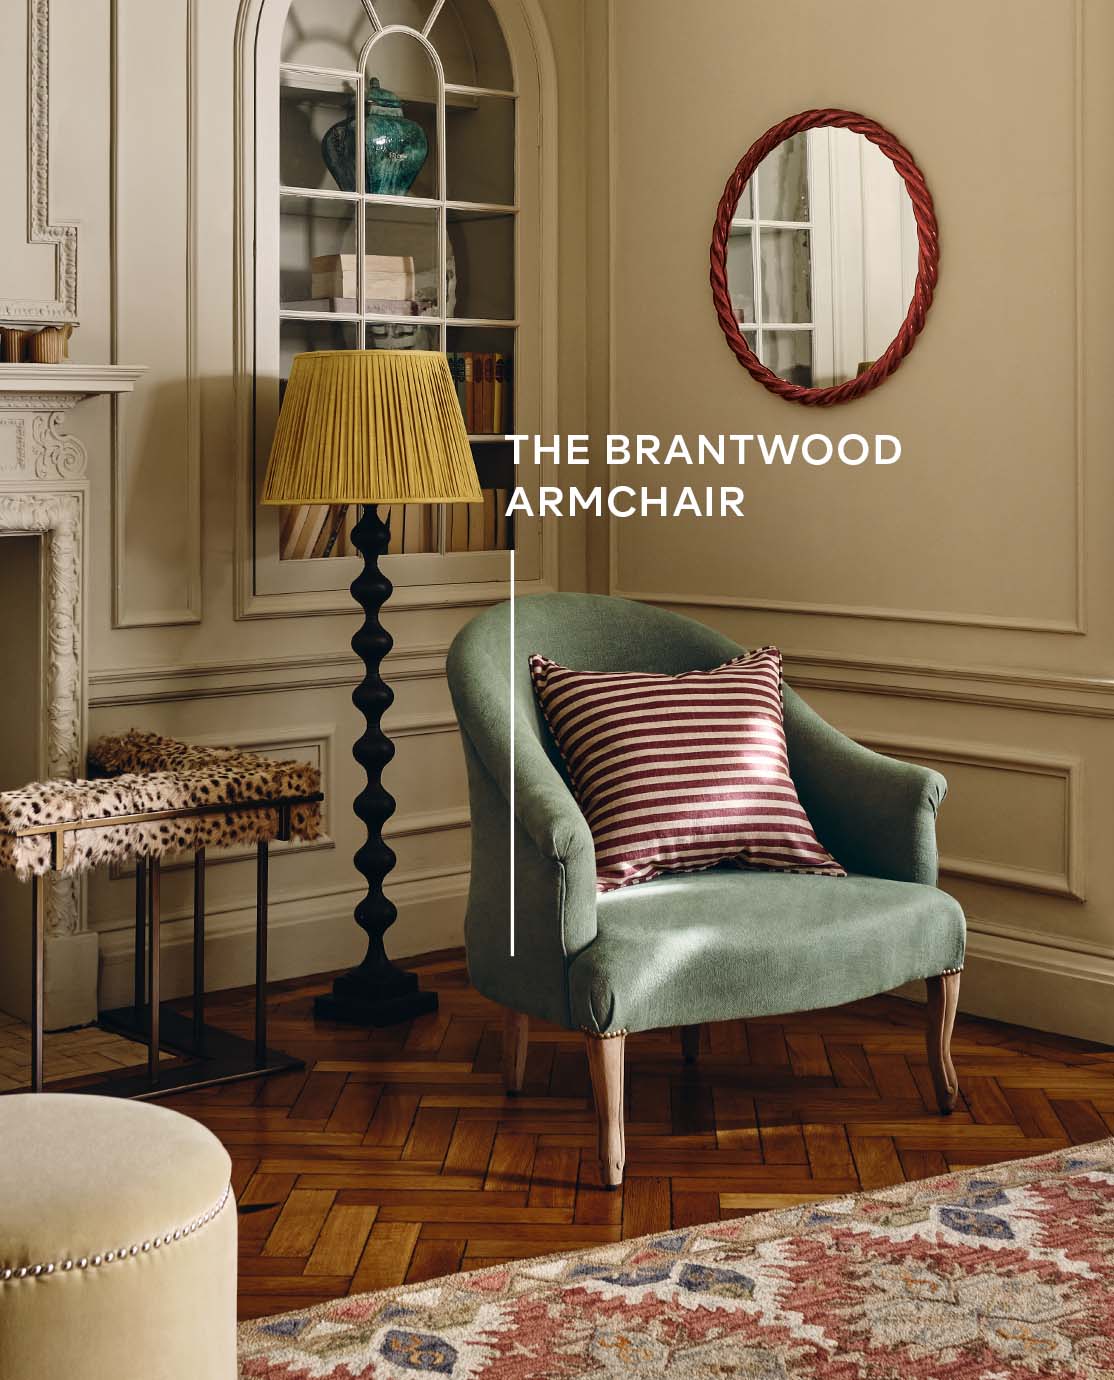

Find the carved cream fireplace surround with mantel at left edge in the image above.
[{"left": 0, "top": 364, "right": 142, "bottom": 1028}]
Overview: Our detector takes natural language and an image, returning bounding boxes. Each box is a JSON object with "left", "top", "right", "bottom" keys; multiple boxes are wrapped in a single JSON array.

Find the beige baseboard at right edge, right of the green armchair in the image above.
[{"left": 899, "top": 922, "right": 1114, "bottom": 1045}]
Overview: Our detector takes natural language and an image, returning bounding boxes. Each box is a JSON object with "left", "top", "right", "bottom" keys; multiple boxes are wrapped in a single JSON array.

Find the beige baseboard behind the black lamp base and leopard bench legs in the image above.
[{"left": 99, "top": 868, "right": 468, "bottom": 1010}]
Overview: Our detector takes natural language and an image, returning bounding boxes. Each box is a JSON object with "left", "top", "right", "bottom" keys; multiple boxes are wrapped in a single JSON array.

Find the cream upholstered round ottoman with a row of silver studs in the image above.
[{"left": 0, "top": 1093, "right": 236, "bottom": 1380}]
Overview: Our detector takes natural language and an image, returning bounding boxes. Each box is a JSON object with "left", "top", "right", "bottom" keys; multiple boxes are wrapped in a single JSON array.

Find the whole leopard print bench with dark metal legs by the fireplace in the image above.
[{"left": 7, "top": 730, "right": 322, "bottom": 1096}]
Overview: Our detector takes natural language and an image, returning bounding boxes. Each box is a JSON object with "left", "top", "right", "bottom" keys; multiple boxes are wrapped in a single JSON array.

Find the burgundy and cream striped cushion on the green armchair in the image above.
[{"left": 530, "top": 647, "right": 846, "bottom": 891}]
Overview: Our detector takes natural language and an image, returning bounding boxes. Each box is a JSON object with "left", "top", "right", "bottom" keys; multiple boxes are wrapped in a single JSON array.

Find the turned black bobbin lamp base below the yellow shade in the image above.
[{"left": 313, "top": 505, "right": 438, "bottom": 1025}]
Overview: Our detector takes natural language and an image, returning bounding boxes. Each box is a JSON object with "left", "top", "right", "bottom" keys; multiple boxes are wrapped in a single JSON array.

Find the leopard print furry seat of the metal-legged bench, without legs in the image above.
[{"left": 0, "top": 730, "right": 322, "bottom": 880}]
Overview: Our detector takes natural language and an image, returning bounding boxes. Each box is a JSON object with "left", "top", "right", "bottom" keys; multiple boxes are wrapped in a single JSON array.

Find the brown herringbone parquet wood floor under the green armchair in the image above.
[{"left": 156, "top": 955, "right": 1114, "bottom": 1317}]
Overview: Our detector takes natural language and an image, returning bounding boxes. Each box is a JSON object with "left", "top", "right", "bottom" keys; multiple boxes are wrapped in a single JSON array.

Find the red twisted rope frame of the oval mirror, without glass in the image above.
[{"left": 711, "top": 109, "right": 940, "bottom": 407}]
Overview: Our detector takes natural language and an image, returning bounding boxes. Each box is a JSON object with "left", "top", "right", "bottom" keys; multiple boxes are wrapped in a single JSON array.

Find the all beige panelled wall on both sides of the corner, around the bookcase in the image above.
[{"left": 0, "top": 0, "right": 1114, "bottom": 1038}]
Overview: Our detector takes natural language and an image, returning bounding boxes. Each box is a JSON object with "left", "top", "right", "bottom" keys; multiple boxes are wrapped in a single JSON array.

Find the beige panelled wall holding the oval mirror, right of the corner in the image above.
[{"left": 610, "top": 0, "right": 1114, "bottom": 1039}]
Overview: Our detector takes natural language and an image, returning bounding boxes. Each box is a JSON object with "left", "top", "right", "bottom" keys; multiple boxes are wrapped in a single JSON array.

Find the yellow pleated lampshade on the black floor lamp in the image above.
[{"left": 262, "top": 349, "right": 483, "bottom": 504}]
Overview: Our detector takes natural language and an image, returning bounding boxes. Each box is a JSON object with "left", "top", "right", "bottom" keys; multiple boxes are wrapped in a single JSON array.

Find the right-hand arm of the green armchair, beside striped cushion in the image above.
[{"left": 785, "top": 686, "right": 947, "bottom": 886}]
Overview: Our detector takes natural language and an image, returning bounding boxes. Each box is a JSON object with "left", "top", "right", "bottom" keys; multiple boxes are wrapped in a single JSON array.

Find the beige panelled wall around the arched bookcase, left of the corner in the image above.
[{"left": 0, "top": 0, "right": 587, "bottom": 1005}]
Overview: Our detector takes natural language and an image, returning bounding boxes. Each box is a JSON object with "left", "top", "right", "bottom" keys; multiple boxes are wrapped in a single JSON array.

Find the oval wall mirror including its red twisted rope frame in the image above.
[{"left": 711, "top": 110, "right": 940, "bottom": 406}]
